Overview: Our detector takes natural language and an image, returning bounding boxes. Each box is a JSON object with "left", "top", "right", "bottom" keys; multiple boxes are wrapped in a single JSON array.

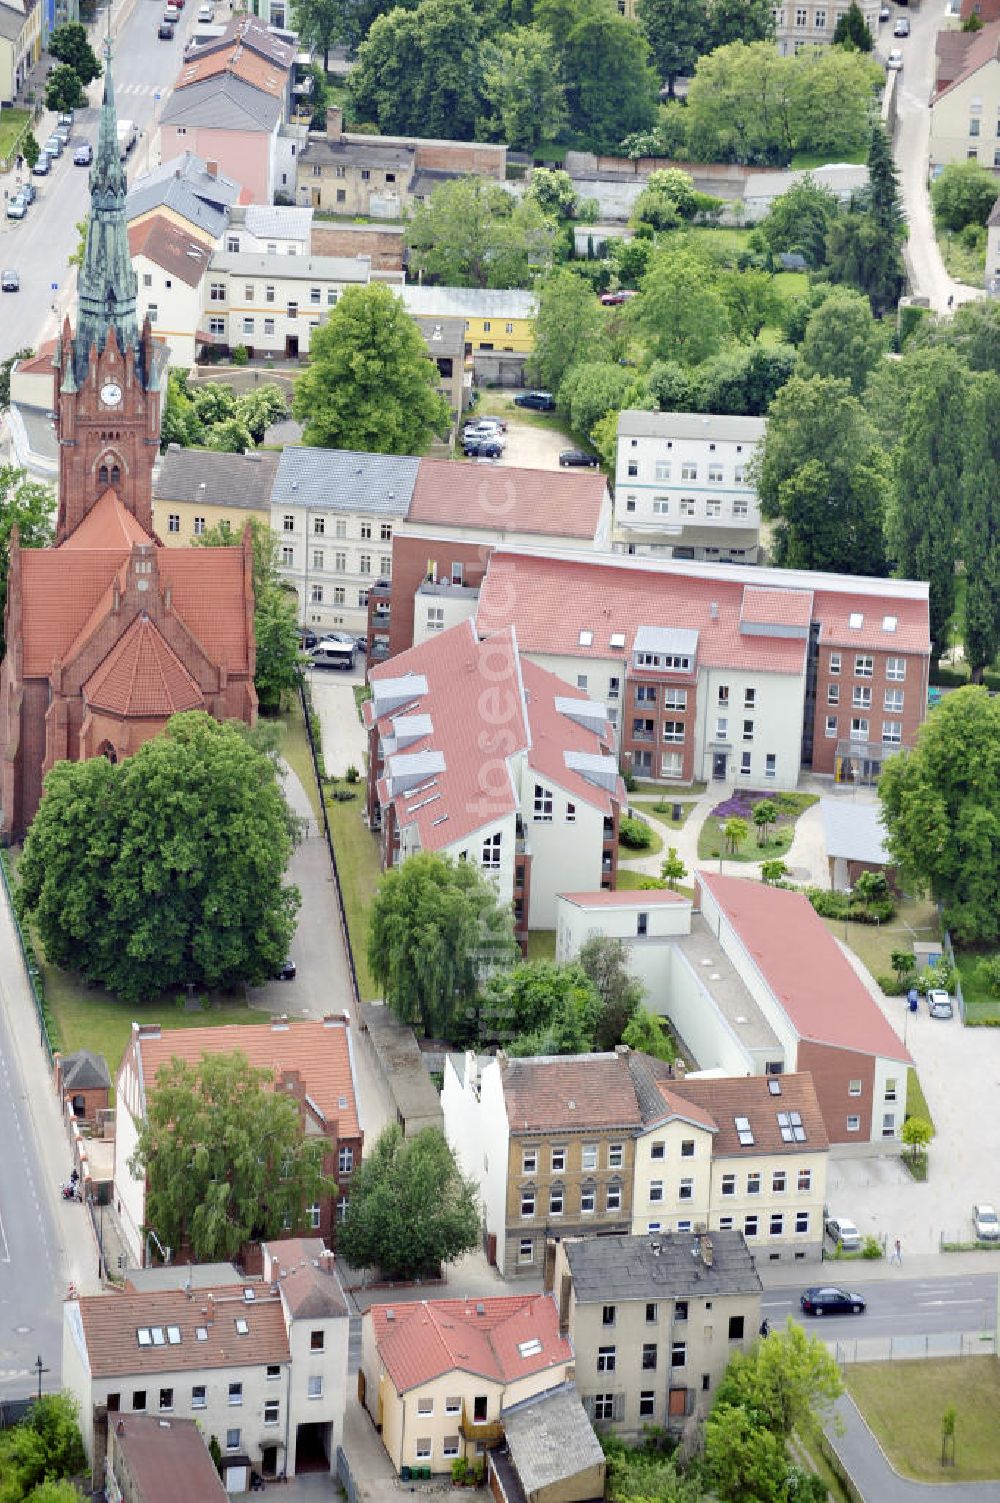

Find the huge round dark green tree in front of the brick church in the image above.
[{"left": 17, "top": 711, "right": 299, "bottom": 1003}]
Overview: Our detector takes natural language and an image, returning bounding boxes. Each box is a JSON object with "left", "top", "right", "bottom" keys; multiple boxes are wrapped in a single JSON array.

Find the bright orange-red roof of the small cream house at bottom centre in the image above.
[{"left": 368, "top": 1294, "right": 573, "bottom": 1393}]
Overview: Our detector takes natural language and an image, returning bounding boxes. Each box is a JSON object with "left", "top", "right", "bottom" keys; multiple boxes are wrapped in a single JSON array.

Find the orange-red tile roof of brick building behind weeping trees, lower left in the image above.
[{"left": 130, "top": 1019, "right": 361, "bottom": 1138}]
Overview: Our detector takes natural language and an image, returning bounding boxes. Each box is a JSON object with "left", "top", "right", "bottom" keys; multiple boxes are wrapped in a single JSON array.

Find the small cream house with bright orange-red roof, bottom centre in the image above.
[{"left": 358, "top": 1294, "right": 573, "bottom": 1479}]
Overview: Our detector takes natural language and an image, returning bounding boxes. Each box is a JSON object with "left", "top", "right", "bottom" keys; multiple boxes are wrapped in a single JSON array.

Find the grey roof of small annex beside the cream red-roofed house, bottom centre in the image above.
[{"left": 502, "top": 1384, "right": 605, "bottom": 1497}]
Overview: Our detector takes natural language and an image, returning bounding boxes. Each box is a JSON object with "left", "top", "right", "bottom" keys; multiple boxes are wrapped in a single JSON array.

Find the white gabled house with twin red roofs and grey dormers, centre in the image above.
[{"left": 364, "top": 621, "right": 624, "bottom": 945}]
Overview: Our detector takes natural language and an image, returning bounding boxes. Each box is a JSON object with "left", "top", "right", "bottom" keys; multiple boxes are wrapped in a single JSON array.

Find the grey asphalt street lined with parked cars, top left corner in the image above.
[{"left": 0, "top": 0, "right": 197, "bottom": 359}]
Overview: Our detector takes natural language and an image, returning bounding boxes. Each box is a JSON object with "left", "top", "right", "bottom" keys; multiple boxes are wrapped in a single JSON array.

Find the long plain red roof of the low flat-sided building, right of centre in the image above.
[{"left": 698, "top": 870, "right": 910, "bottom": 1063}]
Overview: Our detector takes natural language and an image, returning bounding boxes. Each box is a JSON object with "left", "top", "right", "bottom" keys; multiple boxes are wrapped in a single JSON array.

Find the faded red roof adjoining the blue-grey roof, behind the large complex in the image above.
[{"left": 406, "top": 460, "right": 608, "bottom": 540}]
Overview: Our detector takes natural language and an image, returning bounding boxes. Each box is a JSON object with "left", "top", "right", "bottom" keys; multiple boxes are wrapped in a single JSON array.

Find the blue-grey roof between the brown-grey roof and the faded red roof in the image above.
[{"left": 271, "top": 445, "right": 420, "bottom": 517}]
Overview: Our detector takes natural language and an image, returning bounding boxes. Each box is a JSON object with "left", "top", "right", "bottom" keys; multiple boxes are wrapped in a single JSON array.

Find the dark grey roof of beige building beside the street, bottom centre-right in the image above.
[{"left": 564, "top": 1231, "right": 761, "bottom": 1305}]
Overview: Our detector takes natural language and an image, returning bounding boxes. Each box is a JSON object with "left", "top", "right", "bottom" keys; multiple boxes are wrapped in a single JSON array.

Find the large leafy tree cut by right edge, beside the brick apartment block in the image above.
[{"left": 878, "top": 687, "right": 1000, "bottom": 944}]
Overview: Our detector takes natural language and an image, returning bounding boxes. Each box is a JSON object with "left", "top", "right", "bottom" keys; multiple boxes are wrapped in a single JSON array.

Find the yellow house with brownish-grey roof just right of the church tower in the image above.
[{"left": 153, "top": 443, "right": 280, "bottom": 549}]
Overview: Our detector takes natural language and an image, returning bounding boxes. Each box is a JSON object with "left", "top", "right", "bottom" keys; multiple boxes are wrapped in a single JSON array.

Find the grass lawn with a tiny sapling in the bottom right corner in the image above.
[{"left": 845, "top": 1357, "right": 1000, "bottom": 1495}]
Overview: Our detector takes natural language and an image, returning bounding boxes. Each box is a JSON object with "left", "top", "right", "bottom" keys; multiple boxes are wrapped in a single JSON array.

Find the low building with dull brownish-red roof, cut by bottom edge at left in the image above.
[{"left": 104, "top": 1414, "right": 229, "bottom": 1503}]
